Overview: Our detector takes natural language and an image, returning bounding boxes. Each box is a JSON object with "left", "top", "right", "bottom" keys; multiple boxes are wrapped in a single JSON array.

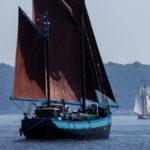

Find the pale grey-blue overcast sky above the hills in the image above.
[{"left": 0, "top": 0, "right": 150, "bottom": 65}]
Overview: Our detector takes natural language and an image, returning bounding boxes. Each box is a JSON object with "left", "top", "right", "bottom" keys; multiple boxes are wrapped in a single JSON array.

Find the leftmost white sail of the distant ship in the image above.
[{"left": 134, "top": 96, "right": 144, "bottom": 115}]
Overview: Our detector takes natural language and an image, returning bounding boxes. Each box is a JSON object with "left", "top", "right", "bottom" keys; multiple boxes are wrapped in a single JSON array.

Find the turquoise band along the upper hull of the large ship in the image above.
[{"left": 52, "top": 115, "right": 112, "bottom": 130}]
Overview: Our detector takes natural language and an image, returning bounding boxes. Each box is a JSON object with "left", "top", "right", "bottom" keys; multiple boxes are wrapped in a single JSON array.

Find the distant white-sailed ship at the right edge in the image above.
[{"left": 134, "top": 85, "right": 150, "bottom": 119}]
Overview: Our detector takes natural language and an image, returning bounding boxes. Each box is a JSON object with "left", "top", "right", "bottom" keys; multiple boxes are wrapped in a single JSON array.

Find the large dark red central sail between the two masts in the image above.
[{"left": 38, "top": 0, "right": 82, "bottom": 101}]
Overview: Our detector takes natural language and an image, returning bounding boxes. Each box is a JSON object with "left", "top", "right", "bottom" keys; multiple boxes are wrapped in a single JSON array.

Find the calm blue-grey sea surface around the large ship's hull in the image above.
[{"left": 0, "top": 115, "right": 150, "bottom": 150}]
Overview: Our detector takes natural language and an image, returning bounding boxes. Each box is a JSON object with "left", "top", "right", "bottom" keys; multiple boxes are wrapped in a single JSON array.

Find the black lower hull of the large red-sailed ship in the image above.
[{"left": 22, "top": 118, "right": 111, "bottom": 139}]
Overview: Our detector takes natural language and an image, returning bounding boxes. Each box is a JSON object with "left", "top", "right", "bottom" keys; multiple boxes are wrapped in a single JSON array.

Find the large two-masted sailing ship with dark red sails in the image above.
[{"left": 11, "top": 0, "right": 117, "bottom": 139}]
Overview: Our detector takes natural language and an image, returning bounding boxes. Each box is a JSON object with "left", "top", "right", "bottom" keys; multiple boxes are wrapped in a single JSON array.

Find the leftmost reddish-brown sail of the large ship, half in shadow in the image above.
[{"left": 13, "top": 8, "right": 46, "bottom": 99}]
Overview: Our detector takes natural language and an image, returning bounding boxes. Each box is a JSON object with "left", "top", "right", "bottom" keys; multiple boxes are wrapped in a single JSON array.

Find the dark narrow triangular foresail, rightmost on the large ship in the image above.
[{"left": 83, "top": 5, "right": 116, "bottom": 102}]
